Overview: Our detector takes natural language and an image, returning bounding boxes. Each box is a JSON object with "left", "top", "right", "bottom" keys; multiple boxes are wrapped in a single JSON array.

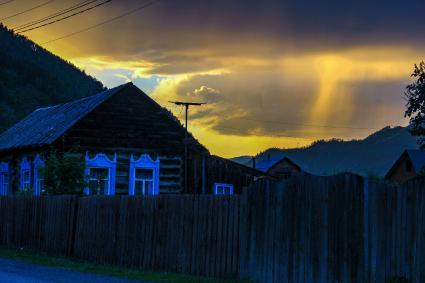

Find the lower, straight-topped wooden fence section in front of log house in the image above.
[{"left": 0, "top": 195, "right": 239, "bottom": 277}]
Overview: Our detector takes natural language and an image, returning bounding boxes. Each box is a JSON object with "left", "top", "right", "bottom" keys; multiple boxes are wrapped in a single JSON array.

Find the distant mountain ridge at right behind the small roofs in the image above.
[{"left": 233, "top": 127, "right": 419, "bottom": 176}]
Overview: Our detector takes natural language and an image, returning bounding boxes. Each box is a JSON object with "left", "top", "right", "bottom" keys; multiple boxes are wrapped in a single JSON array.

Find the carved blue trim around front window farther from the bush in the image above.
[{"left": 128, "top": 154, "right": 160, "bottom": 196}]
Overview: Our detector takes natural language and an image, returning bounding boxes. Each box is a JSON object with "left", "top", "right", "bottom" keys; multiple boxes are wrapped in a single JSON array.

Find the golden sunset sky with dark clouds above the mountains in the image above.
[{"left": 0, "top": 0, "right": 425, "bottom": 157}]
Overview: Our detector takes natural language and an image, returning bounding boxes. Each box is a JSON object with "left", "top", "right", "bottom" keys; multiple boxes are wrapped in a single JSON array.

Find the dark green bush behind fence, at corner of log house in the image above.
[{"left": 44, "top": 152, "right": 85, "bottom": 195}]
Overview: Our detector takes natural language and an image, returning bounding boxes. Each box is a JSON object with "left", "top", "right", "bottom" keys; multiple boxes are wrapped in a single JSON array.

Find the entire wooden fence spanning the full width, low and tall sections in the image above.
[{"left": 0, "top": 174, "right": 425, "bottom": 283}]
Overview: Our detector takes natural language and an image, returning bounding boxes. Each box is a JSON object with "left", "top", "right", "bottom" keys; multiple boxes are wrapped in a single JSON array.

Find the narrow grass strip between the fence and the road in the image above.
[{"left": 0, "top": 247, "right": 249, "bottom": 283}]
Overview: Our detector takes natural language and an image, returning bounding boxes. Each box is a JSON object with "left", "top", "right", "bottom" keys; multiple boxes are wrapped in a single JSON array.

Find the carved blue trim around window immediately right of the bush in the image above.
[{"left": 84, "top": 152, "right": 117, "bottom": 196}]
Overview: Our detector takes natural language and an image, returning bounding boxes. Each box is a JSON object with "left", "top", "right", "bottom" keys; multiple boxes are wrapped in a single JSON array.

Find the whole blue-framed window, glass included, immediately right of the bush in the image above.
[{"left": 84, "top": 152, "right": 117, "bottom": 195}]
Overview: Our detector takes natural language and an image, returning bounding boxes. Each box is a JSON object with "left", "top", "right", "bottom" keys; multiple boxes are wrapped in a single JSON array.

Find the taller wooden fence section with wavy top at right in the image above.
[{"left": 240, "top": 174, "right": 425, "bottom": 283}]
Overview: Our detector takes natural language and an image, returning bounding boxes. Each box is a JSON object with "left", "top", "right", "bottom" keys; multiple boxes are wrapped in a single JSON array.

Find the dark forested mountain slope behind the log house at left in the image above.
[{"left": 0, "top": 24, "right": 104, "bottom": 132}]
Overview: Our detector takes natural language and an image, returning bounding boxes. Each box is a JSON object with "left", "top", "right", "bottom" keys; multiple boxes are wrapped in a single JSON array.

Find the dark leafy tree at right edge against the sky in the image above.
[{"left": 404, "top": 62, "right": 425, "bottom": 149}]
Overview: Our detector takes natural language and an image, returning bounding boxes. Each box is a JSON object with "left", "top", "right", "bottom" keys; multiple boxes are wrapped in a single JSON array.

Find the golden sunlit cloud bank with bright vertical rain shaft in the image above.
[{"left": 142, "top": 47, "right": 419, "bottom": 142}]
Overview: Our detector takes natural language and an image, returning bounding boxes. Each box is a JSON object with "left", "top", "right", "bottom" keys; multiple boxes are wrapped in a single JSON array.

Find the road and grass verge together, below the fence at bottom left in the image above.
[{"left": 0, "top": 246, "right": 245, "bottom": 283}]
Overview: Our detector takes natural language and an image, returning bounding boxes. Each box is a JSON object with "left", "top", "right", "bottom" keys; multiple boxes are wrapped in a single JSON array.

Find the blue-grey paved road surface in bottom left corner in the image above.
[{"left": 0, "top": 258, "right": 147, "bottom": 283}]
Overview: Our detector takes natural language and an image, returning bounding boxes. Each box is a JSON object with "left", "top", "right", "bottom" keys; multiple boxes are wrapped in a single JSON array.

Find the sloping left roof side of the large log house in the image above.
[{"left": 0, "top": 83, "right": 127, "bottom": 151}]
